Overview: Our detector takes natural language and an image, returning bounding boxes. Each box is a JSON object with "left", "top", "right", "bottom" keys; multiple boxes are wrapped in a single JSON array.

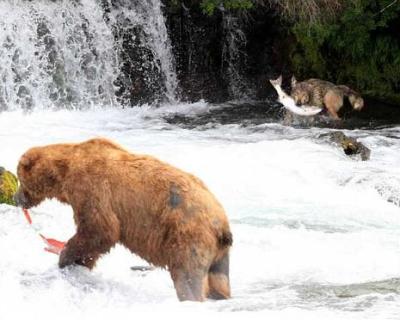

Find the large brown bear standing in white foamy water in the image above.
[{"left": 14, "top": 139, "right": 232, "bottom": 301}]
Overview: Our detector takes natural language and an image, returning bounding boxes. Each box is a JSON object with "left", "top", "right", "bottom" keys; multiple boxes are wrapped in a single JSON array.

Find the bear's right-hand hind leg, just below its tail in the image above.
[{"left": 208, "top": 253, "right": 231, "bottom": 300}]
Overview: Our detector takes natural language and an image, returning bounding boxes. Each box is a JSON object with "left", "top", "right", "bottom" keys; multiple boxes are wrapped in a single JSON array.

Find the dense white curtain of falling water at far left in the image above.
[{"left": 0, "top": 0, "right": 118, "bottom": 109}]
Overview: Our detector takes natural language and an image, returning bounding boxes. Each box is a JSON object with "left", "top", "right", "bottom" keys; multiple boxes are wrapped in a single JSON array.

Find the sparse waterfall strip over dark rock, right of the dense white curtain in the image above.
[{"left": 108, "top": 0, "right": 178, "bottom": 102}]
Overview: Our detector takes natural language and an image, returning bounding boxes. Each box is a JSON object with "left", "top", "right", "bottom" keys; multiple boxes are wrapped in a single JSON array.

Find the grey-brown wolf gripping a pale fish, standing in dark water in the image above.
[{"left": 291, "top": 77, "right": 364, "bottom": 119}]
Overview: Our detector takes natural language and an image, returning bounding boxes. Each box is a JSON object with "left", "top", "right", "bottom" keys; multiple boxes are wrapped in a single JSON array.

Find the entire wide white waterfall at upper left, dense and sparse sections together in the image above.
[{"left": 0, "top": 0, "right": 178, "bottom": 110}]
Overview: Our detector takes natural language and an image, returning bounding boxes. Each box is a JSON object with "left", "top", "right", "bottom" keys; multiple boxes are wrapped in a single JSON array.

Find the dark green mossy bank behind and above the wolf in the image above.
[{"left": 291, "top": 0, "right": 400, "bottom": 102}]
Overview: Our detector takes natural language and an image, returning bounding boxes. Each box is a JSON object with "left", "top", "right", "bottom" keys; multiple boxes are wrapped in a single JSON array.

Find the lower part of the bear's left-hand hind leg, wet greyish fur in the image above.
[{"left": 170, "top": 269, "right": 208, "bottom": 301}]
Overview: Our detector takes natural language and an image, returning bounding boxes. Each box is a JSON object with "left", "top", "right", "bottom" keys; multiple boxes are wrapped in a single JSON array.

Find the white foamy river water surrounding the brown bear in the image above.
[{"left": 0, "top": 102, "right": 400, "bottom": 319}]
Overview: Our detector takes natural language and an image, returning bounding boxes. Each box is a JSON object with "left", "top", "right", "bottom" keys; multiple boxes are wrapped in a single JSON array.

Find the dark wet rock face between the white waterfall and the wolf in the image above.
[{"left": 164, "top": 1, "right": 288, "bottom": 102}]
